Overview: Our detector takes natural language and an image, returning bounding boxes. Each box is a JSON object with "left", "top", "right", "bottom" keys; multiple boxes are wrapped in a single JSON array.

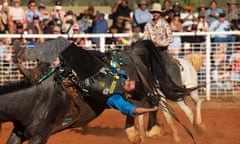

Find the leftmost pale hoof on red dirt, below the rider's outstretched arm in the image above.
[{"left": 125, "top": 126, "right": 143, "bottom": 144}]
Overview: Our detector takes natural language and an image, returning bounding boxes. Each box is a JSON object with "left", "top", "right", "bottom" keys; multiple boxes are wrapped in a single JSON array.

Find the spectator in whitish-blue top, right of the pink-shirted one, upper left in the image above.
[{"left": 26, "top": 0, "right": 40, "bottom": 24}]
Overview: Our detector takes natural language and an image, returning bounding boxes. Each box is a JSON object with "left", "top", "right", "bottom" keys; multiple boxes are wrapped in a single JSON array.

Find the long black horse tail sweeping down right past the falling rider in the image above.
[{"left": 130, "top": 40, "right": 194, "bottom": 101}]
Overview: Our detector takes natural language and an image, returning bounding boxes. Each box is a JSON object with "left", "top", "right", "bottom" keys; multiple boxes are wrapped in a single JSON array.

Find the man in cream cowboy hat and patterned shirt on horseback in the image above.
[{"left": 144, "top": 3, "right": 182, "bottom": 86}]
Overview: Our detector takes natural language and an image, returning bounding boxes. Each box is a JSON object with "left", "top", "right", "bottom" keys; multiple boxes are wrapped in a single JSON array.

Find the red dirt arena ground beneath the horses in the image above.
[{"left": 0, "top": 99, "right": 240, "bottom": 144}]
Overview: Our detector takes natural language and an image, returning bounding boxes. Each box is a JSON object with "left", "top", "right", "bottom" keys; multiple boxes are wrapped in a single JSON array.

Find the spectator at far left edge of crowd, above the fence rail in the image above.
[{"left": 0, "top": 2, "right": 11, "bottom": 34}]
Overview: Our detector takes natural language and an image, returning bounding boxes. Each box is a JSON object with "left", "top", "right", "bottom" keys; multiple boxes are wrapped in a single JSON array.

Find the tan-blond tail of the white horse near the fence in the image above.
[{"left": 184, "top": 53, "right": 203, "bottom": 72}]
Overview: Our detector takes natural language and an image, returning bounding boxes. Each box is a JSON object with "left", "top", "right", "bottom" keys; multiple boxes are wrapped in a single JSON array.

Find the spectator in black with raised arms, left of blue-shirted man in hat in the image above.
[{"left": 111, "top": 0, "right": 132, "bottom": 23}]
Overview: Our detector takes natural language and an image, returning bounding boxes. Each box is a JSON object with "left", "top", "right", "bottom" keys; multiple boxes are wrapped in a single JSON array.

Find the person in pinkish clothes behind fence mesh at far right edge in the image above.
[{"left": 229, "top": 45, "right": 240, "bottom": 90}]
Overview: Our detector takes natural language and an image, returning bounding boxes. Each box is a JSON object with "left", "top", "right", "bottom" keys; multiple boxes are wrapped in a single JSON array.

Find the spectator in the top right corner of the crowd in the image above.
[{"left": 226, "top": 0, "right": 240, "bottom": 22}]
